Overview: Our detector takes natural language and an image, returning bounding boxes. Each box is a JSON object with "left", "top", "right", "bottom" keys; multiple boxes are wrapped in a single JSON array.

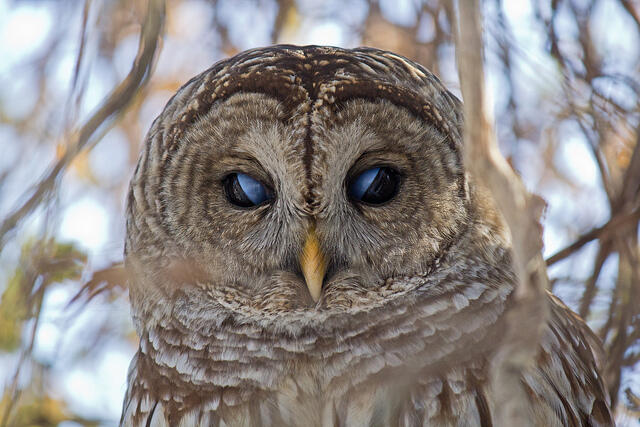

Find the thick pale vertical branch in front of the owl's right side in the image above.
[{"left": 456, "top": 1, "right": 548, "bottom": 426}]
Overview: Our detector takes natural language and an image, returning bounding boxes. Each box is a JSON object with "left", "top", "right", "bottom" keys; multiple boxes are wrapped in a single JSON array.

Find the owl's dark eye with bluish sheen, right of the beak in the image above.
[{"left": 349, "top": 167, "right": 400, "bottom": 205}]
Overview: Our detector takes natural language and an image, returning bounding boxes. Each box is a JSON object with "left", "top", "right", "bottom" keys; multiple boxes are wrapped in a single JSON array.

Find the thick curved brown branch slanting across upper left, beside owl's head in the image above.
[{"left": 0, "top": 0, "right": 165, "bottom": 247}]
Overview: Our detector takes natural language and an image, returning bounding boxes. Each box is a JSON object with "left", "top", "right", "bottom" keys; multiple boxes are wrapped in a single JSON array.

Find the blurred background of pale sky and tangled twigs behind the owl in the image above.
[{"left": 0, "top": 0, "right": 640, "bottom": 427}]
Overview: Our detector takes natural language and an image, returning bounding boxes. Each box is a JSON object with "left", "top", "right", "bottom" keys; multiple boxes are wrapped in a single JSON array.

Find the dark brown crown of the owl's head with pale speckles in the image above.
[{"left": 162, "top": 45, "right": 462, "bottom": 155}]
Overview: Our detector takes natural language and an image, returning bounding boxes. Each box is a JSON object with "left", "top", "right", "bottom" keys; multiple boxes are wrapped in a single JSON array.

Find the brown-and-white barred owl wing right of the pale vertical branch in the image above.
[{"left": 523, "top": 293, "right": 614, "bottom": 426}]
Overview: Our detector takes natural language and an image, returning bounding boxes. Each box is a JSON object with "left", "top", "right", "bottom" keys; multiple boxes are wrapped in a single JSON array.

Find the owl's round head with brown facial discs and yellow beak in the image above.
[{"left": 126, "top": 46, "right": 507, "bottom": 334}]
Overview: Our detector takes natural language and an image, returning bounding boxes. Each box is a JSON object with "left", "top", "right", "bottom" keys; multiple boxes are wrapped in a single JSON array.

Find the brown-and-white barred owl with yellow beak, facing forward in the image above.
[{"left": 121, "top": 45, "right": 613, "bottom": 426}]
